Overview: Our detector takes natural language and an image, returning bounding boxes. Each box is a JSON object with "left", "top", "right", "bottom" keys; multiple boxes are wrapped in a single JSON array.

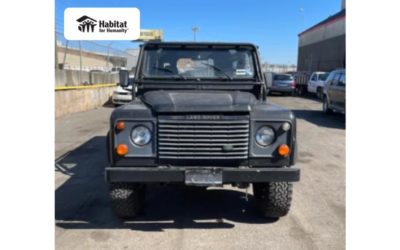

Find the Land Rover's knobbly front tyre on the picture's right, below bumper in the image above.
[{"left": 253, "top": 182, "right": 293, "bottom": 218}]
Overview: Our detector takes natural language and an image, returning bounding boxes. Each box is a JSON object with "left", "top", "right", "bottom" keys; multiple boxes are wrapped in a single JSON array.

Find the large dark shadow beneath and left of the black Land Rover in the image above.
[{"left": 55, "top": 136, "right": 276, "bottom": 231}]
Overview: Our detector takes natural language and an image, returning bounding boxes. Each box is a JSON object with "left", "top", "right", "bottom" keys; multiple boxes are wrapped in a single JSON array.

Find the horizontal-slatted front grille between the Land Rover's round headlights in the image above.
[{"left": 158, "top": 118, "right": 249, "bottom": 160}]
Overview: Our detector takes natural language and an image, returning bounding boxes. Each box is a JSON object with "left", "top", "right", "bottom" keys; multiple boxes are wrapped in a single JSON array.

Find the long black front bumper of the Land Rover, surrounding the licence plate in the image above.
[{"left": 105, "top": 167, "right": 300, "bottom": 183}]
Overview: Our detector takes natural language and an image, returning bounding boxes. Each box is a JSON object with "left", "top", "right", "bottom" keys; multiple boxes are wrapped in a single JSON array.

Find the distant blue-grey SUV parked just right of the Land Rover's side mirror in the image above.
[{"left": 267, "top": 73, "right": 296, "bottom": 95}]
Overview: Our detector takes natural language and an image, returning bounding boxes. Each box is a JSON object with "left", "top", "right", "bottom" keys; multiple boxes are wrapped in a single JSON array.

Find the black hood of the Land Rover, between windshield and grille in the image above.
[{"left": 142, "top": 90, "right": 257, "bottom": 113}]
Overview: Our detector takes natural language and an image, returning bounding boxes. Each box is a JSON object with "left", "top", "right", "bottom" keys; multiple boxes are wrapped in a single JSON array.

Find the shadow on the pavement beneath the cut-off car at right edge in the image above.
[{"left": 292, "top": 109, "right": 346, "bottom": 129}]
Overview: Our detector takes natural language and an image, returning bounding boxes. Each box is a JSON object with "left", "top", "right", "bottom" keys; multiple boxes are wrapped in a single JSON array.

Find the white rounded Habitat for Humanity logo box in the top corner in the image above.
[{"left": 64, "top": 8, "right": 140, "bottom": 40}]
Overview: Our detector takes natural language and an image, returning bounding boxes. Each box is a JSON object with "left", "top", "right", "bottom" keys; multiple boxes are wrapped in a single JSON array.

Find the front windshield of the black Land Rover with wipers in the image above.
[{"left": 142, "top": 48, "right": 254, "bottom": 80}]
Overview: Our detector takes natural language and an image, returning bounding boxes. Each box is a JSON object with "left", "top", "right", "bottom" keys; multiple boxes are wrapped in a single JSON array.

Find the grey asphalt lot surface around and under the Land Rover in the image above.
[{"left": 55, "top": 96, "right": 346, "bottom": 250}]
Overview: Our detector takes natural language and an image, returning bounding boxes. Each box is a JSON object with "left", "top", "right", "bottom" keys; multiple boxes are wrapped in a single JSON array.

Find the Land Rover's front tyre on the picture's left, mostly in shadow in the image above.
[{"left": 110, "top": 182, "right": 145, "bottom": 218}]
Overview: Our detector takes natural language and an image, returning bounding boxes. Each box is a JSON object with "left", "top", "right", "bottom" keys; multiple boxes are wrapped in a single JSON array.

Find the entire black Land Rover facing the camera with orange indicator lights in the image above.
[{"left": 105, "top": 42, "right": 300, "bottom": 217}]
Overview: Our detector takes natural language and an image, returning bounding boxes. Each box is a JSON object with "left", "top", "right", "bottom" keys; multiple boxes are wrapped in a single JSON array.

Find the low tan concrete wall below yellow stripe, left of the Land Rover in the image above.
[{"left": 55, "top": 87, "right": 115, "bottom": 118}]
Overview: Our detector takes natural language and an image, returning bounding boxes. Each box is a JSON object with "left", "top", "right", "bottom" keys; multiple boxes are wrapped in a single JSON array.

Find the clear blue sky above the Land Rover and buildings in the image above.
[{"left": 55, "top": 0, "right": 341, "bottom": 64}]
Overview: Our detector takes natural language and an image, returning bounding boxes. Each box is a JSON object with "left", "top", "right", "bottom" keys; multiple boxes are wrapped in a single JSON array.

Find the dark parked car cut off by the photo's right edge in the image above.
[{"left": 322, "top": 69, "right": 346, "bottom": 114}]
